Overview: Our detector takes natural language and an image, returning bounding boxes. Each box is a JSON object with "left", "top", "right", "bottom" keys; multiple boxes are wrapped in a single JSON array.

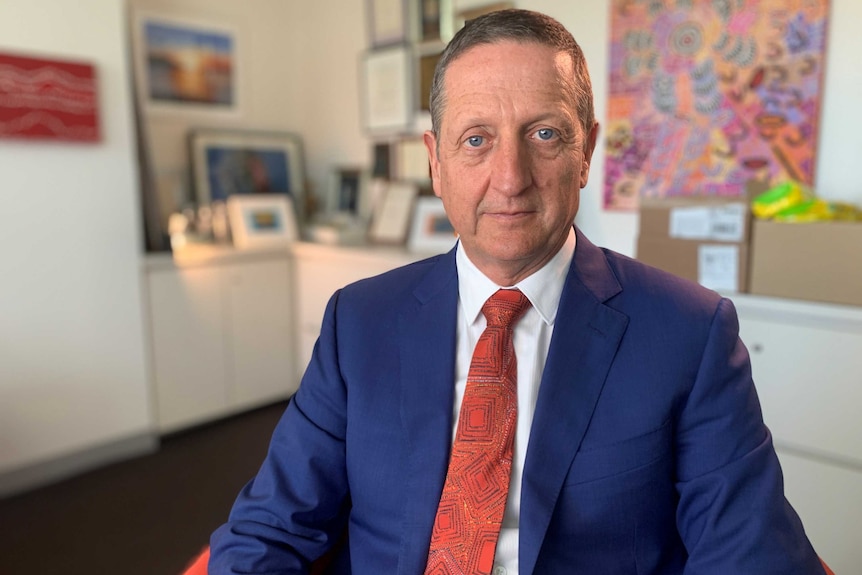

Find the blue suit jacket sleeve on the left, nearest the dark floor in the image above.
[{"left": 209, "top": 293, "right": 349, "bottom": 575}]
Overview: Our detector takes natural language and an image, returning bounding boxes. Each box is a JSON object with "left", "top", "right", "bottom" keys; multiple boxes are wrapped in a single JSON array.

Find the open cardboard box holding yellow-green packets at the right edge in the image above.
[{"left": 750, "top": 220, "right": 862, "bottom": 305}]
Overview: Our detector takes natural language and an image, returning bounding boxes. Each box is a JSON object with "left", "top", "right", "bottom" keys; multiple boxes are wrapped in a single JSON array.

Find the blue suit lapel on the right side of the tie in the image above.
[{"left": 519, "top": 232, "right": 628, "bottom": 574}]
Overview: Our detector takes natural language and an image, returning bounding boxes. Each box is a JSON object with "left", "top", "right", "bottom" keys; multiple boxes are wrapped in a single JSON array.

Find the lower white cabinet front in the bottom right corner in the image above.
[{"left": 778, "top": 449, "right": 862, "bottom": 573}]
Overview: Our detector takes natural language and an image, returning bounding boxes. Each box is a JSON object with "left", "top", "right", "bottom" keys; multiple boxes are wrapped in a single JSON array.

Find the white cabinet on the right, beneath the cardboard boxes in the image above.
[{"left": 732, "top": 295, "right": 862, "bottom": 573}]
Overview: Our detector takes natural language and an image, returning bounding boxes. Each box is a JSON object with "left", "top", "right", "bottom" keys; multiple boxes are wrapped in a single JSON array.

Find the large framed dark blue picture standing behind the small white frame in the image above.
[{"left": 189, "top": 129, "right": 305, "bottom": 223}]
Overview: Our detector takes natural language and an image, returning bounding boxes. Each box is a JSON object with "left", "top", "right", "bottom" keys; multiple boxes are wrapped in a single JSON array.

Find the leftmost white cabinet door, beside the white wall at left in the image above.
[{"left": 149, "top": 268, "right": 228, "bottom": 432}]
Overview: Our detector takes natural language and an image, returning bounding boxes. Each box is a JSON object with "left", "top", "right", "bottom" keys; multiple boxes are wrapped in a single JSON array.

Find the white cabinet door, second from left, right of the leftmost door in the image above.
[{"left": 224, "top": 258, "right": 298, "bottom": 407}]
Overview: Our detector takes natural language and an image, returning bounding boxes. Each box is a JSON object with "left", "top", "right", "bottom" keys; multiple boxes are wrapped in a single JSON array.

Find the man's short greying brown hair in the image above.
[{"left": 429, "top": 9, "right": 596, "bottom": 137}]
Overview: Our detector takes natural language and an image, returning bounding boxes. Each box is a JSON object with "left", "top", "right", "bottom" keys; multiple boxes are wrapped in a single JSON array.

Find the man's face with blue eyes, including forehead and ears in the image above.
[{"left": 425, "top": 41, "right": 597, "bottom": 285}]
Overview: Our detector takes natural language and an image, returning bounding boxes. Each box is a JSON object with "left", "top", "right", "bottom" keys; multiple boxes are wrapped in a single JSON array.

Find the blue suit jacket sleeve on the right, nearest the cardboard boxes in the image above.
[{"left": 676, "top": 299, "right": 823, "bottom": 575}]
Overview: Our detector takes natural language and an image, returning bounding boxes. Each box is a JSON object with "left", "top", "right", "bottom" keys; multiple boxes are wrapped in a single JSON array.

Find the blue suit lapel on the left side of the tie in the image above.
[{"left": 398, "top": 250, "right": 458, "bottom": 574}]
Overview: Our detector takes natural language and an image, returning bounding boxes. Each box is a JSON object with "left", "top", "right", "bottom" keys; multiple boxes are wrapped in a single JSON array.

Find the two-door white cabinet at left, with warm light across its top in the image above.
[{"left": 147, "top": 252, "right": 298, "bottom": 432}]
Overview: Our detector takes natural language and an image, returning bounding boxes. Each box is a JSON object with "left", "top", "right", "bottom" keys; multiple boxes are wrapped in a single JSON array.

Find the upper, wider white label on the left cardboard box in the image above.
[{"left": 668, "top": 203, "right": 746, "bottom": 242}]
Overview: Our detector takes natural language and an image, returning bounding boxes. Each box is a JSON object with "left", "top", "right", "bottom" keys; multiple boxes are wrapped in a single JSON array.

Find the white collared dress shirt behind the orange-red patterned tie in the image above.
[{"left": 452, "top": 229, "right": 575, "bottom": 575}]
